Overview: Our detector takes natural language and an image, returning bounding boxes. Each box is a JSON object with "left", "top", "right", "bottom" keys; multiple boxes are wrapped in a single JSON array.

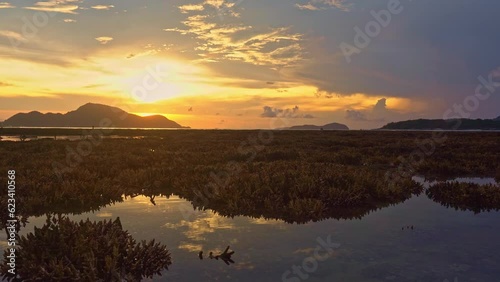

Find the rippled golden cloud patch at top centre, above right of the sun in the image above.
[{"left": 164, "top": 0, "right": 305, "bottom": 68}]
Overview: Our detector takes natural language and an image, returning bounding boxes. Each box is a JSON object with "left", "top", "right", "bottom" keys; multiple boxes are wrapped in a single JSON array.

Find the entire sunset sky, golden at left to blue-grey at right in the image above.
[{"left": 0, "top": 0, "right": 500, "bottom": 129}]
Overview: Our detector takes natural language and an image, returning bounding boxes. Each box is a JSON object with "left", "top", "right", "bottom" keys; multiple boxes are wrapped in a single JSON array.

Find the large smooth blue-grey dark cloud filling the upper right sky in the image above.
[{"left": 293, "top": 0, "right": 500, "bottom": 120}]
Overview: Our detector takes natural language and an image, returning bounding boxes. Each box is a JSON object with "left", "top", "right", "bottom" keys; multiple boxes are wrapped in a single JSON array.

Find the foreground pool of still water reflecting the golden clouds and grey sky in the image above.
[{"left": 1, "top": 195, "right": 500, "bottom": 282}]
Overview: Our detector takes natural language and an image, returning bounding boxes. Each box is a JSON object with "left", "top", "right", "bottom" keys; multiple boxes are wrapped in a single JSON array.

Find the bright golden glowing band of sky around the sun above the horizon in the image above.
[{"left": 0, "top": 42, "right": 426, "bottom": 128}]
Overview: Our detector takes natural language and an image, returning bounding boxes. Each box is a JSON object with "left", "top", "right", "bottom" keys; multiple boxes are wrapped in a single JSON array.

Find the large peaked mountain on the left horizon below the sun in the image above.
[{"left": 3, "top": 103, "right": 187, "bottom": 128}]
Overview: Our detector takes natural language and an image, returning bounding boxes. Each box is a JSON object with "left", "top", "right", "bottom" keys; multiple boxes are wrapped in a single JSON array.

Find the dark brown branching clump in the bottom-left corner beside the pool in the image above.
[{"left": 1, "top": 215, "right": 171, "bottom": 281}]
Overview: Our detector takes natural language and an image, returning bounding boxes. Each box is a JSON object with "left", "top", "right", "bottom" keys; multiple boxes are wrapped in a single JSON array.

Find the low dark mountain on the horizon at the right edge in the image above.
[{"left": 381, "top": 117, "right": 500, "bottom": 130}]
